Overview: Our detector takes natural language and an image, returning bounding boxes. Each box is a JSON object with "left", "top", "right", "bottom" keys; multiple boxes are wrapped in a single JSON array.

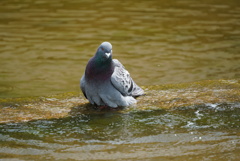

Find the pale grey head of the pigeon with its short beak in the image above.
[{"left": 96, "top": 42, "right": 112, "bottom": 61}]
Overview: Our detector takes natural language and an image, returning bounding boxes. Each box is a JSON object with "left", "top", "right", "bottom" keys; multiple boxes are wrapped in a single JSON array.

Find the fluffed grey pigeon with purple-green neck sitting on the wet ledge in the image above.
[{"left": 80, "top": 42, "right": 144, "bottom": 108}]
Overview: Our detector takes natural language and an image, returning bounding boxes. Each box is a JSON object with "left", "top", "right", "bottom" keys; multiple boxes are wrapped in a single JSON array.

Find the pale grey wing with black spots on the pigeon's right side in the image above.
[{"left": 111, "top": 59, "right": 144, "bottom": 97}]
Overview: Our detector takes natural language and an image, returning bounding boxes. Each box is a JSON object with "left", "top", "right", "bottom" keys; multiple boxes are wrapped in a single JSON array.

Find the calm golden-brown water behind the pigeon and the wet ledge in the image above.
[{"left": 0, "top": 0, "right": 240, "bottom": 98}]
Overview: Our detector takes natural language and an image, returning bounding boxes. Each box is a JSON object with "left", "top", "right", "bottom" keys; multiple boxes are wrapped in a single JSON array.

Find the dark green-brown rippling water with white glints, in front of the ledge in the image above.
[{"left": 0, "top": 104, "right": 240, "bottom": 160}]
